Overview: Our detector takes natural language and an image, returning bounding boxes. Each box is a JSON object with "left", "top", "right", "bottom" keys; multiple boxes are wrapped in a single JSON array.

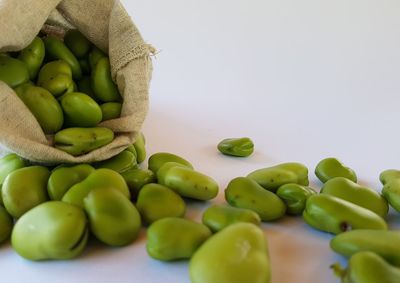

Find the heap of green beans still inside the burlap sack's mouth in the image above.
[{"left": 0, "top": 29, "right": 122, "bottom": 156}]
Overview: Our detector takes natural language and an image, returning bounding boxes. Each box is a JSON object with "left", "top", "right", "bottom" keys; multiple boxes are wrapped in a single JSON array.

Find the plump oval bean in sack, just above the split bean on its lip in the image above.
[{"left": 61, "top": 92, "right": 103, "bottom": 128}]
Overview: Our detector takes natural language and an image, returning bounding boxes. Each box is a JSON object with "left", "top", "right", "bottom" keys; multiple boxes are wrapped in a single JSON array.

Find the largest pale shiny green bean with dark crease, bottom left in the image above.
[{"left": 11, "top": 201, "right": 89, "bottom": 260}]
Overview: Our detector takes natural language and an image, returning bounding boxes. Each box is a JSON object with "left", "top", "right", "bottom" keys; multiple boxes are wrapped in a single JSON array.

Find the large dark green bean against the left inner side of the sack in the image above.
[{"left": 17, "top": 85, "right": 64, "bottom": 134}]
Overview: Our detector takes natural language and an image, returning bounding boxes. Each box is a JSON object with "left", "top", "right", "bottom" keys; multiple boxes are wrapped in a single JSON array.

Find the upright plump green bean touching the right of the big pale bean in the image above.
[{"left": 84, "top": 187, "right": 141, "bottom": 246}]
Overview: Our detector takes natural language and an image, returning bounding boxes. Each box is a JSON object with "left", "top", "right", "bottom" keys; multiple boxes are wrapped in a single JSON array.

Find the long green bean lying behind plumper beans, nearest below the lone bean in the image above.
[{"left": 247, "top": 162, "right": 308, "bottom": 192}]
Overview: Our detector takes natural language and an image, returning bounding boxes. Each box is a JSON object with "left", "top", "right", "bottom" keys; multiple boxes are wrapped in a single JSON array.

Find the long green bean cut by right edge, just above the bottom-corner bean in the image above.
[{"left": 330, "top": 229, "right": 400, "bottom": 266}]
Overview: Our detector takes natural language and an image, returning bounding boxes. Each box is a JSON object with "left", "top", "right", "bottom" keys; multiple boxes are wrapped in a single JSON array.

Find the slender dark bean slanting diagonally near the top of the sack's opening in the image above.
[{"left": 43, "top": 36, "right": 82, "bottom": 80}]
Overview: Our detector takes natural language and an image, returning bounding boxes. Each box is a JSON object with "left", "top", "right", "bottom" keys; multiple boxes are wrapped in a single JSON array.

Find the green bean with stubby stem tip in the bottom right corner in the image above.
[{"left": 331, "top": 252, "right": 400, "bottom": 283}]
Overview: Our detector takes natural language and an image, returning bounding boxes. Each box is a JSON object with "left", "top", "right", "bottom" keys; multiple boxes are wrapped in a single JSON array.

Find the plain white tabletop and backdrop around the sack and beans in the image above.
[{"left": 0, "top": 0, "right": 400, "bottom": 283}]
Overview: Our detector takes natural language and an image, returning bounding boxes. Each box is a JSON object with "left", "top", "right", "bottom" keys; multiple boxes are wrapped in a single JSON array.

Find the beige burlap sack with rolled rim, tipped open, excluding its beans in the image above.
[{"left": 0, "top": 0, "right": 153, "bottom": 163}]
